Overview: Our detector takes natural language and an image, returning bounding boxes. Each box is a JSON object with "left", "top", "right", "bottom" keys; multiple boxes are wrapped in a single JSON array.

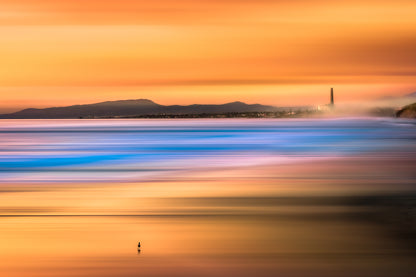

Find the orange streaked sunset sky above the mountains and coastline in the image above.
[{"left": 0, "top": 0, "right": 416, "bottom": 112}]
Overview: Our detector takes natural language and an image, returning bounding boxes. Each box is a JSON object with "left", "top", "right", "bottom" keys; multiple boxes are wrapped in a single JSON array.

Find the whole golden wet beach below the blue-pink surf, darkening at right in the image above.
[{"left": 0, "top": 178, "right": 416, "bottom": 276}]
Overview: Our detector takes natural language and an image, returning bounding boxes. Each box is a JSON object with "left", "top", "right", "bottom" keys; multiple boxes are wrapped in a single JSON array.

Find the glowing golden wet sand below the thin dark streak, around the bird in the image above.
[{"left": 1, "top": 211, "right": 414, "bottom": 276}]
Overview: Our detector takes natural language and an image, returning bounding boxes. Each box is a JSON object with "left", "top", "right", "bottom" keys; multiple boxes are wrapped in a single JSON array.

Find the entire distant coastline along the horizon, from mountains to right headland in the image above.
[{"left": 0, "top": 98, "right": 415, "bottom": 119}]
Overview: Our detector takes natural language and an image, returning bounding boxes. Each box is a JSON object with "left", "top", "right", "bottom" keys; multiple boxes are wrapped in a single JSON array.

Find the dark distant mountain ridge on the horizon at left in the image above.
[{"left": 0, "top": 99, "right": 278, "bottom": 119}]
